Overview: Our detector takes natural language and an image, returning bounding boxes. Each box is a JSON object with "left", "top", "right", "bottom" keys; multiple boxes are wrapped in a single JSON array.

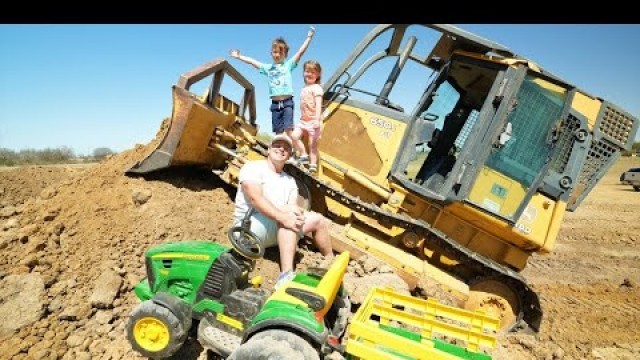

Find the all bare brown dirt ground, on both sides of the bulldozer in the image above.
[{"left": 0, "top": 133, "right": 640, "bottom": 360}]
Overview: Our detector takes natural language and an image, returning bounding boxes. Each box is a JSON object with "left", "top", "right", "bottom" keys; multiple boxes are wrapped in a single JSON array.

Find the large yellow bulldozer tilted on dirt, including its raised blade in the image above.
[{"left": 128, "top": 24, "right": 638, "bottom": 331}]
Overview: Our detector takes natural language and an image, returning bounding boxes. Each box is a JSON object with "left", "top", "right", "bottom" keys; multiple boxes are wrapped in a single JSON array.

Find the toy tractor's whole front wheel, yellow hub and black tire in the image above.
[{"left": 127, "top": 300, "right": 188, "bottom": 359}]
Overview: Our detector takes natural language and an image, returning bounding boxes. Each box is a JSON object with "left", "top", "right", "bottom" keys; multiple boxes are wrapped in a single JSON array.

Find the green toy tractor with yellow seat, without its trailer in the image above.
[{"left": 127, "top": 215, "right": 351, "bottom": 359}]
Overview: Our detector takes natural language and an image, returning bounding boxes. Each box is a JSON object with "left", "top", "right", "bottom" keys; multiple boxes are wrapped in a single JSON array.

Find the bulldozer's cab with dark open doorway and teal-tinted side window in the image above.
[{"left": 392, "top": 60, "right": 568, "bottom": 224}]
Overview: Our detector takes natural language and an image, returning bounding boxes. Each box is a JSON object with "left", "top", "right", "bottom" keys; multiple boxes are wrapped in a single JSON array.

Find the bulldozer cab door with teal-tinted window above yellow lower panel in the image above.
[{"left": 460, "top": 65, "right": 566, "bottom": 224}]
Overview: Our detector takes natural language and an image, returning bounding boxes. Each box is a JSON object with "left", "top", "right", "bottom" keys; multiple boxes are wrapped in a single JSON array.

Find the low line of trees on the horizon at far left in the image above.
[{"left": 0, "top": 146, "right": 115, "bottom": 166}]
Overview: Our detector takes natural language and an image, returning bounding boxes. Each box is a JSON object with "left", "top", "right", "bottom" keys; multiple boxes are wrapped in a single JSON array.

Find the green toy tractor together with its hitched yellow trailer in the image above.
[{"left": 126, "top": 226, "right": 499, "bottom": 360}]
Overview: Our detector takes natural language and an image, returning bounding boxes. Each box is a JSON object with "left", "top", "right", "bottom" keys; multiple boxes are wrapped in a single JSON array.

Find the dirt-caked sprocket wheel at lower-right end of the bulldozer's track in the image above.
[{"left": 464, "top": 279, "right": 521, "bottom": 332}]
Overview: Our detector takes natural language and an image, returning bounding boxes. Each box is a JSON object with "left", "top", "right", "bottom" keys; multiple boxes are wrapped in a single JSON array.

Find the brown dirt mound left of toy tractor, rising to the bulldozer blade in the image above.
[{"left": 0, "top": 126, "right": 238, "bottom": 359}]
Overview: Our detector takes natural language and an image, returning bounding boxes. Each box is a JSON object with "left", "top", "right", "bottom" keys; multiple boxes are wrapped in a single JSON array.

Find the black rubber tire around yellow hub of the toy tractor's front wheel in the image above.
[{"left": 126, "top": 300, "right": 190, "bottom": 359}]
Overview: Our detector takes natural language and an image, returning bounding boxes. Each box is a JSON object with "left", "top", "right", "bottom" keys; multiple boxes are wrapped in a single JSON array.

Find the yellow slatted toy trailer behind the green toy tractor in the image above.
[{"left": 346, "top": 287, "right": 500, "bottom": 360}]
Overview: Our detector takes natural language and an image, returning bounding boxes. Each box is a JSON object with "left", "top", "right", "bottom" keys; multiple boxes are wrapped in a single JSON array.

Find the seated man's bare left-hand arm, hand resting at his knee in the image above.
[{"left": 240, "top": 181, "right": 304, "bottom": 232}]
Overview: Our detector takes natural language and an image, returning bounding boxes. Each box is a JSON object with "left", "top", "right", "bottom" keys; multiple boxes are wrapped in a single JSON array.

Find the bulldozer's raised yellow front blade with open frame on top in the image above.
[{"left": 126, "top": 59, "right": 257, "bottom": 174}]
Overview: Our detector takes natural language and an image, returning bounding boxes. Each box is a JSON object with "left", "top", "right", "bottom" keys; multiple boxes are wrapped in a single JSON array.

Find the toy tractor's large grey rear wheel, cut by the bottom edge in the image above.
[{"left": 228, "top": 329, "right": 320, "bottom": 360}]
